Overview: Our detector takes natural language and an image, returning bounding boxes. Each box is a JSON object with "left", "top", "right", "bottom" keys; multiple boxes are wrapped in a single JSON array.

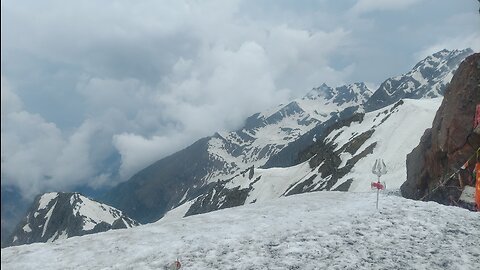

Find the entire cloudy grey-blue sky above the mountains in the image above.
[{"left": 1, "top": 0, "right": 480, "bottom": 196}]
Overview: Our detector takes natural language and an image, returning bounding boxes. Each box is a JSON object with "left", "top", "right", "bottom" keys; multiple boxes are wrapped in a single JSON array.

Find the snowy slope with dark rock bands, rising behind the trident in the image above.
[{"left": 182, "top": 98, "right": 442, "bottom": 215}]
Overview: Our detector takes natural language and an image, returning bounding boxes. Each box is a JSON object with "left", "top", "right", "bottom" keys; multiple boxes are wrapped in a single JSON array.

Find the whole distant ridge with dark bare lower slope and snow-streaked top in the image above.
[{"left": 106, "top": 83, "right": 371, "bottom": 222}]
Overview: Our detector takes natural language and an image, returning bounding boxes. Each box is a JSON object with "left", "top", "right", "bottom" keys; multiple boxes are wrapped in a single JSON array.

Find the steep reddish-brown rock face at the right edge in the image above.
[{"left": 401, "top": 53, "right": 480, "bottom": 204}]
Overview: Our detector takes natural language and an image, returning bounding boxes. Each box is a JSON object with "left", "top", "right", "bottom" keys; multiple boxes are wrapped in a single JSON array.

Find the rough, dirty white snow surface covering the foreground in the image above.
[{"left": 1, "top": 192, "right": 480, "bottom": 270}]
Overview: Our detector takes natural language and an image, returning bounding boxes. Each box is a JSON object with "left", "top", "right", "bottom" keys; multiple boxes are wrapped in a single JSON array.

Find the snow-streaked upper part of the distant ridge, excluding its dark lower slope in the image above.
[{"left": 206, "top": 83, "right": 372, "bottom": 171}]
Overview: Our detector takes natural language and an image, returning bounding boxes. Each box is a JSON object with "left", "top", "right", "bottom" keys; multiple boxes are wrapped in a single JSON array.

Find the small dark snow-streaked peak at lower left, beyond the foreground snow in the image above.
[{"left": 7, "top": 192, "right": 140, "bottom": 245}]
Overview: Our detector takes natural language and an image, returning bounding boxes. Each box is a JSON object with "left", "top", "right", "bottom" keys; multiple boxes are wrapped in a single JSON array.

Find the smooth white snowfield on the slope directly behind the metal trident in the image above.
[{"left": 329, "top": 98, "right": 443, "bottom": 191}]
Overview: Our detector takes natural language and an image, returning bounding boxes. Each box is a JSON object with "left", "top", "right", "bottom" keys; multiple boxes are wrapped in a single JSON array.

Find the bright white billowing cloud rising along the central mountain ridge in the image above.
[{"left": 100, "top": 25, "right": 348, "bottom": 179}]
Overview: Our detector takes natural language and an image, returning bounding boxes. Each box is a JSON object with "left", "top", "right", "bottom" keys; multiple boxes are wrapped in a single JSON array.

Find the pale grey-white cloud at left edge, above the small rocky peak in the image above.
[{"left": 1, "top": 78, "right": 119, "bottom": 198}]
